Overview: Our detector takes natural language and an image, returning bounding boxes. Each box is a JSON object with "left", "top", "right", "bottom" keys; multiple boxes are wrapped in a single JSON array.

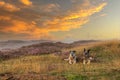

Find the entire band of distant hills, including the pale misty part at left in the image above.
[{"left": 0, "top": 40, "right": 98, "bottom": 59}]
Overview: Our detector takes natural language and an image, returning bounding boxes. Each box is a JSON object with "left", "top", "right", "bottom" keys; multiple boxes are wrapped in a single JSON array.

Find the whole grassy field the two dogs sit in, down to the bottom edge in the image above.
[{"left": 0, "top": 41, "right": 120, "bottom": 80}]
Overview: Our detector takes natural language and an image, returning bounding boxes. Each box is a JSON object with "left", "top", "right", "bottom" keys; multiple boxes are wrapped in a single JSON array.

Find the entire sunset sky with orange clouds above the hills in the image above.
[{"left": 0, "top": 0, "right": 120, "bottom": 42}]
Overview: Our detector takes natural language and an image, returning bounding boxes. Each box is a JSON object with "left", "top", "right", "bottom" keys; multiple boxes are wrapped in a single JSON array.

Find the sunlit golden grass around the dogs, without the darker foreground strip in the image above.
[{"left": 0, "top": 41, "right": 120, "bottom": 79}]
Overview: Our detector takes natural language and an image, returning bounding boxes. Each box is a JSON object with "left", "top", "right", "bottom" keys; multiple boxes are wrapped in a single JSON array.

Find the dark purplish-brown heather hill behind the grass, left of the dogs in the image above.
[{"left": 0, "top": 42, "right": 72, "bottom": 59}]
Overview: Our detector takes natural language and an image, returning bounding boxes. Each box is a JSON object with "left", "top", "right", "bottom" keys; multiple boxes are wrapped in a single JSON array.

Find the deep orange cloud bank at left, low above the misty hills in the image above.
[{"left": 0, "top": 19, "right": 49, "bottom": 38}]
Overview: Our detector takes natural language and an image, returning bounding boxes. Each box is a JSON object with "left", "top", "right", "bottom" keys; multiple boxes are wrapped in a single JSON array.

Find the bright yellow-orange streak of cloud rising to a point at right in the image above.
[{"left": 43, "top": 3, "right": 106, "bottom": 31}]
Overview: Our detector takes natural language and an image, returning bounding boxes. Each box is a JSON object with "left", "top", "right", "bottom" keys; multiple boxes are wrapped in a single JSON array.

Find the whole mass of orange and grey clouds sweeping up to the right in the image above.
[{"left": 0, "top": 0, "right": 106, "bottom": 39}]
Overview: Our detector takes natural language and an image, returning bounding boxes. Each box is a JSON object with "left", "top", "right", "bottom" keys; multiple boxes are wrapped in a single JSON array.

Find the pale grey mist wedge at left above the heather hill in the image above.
[{"left": 0, "top": 40, "right": 52, "bottom": 50}]
